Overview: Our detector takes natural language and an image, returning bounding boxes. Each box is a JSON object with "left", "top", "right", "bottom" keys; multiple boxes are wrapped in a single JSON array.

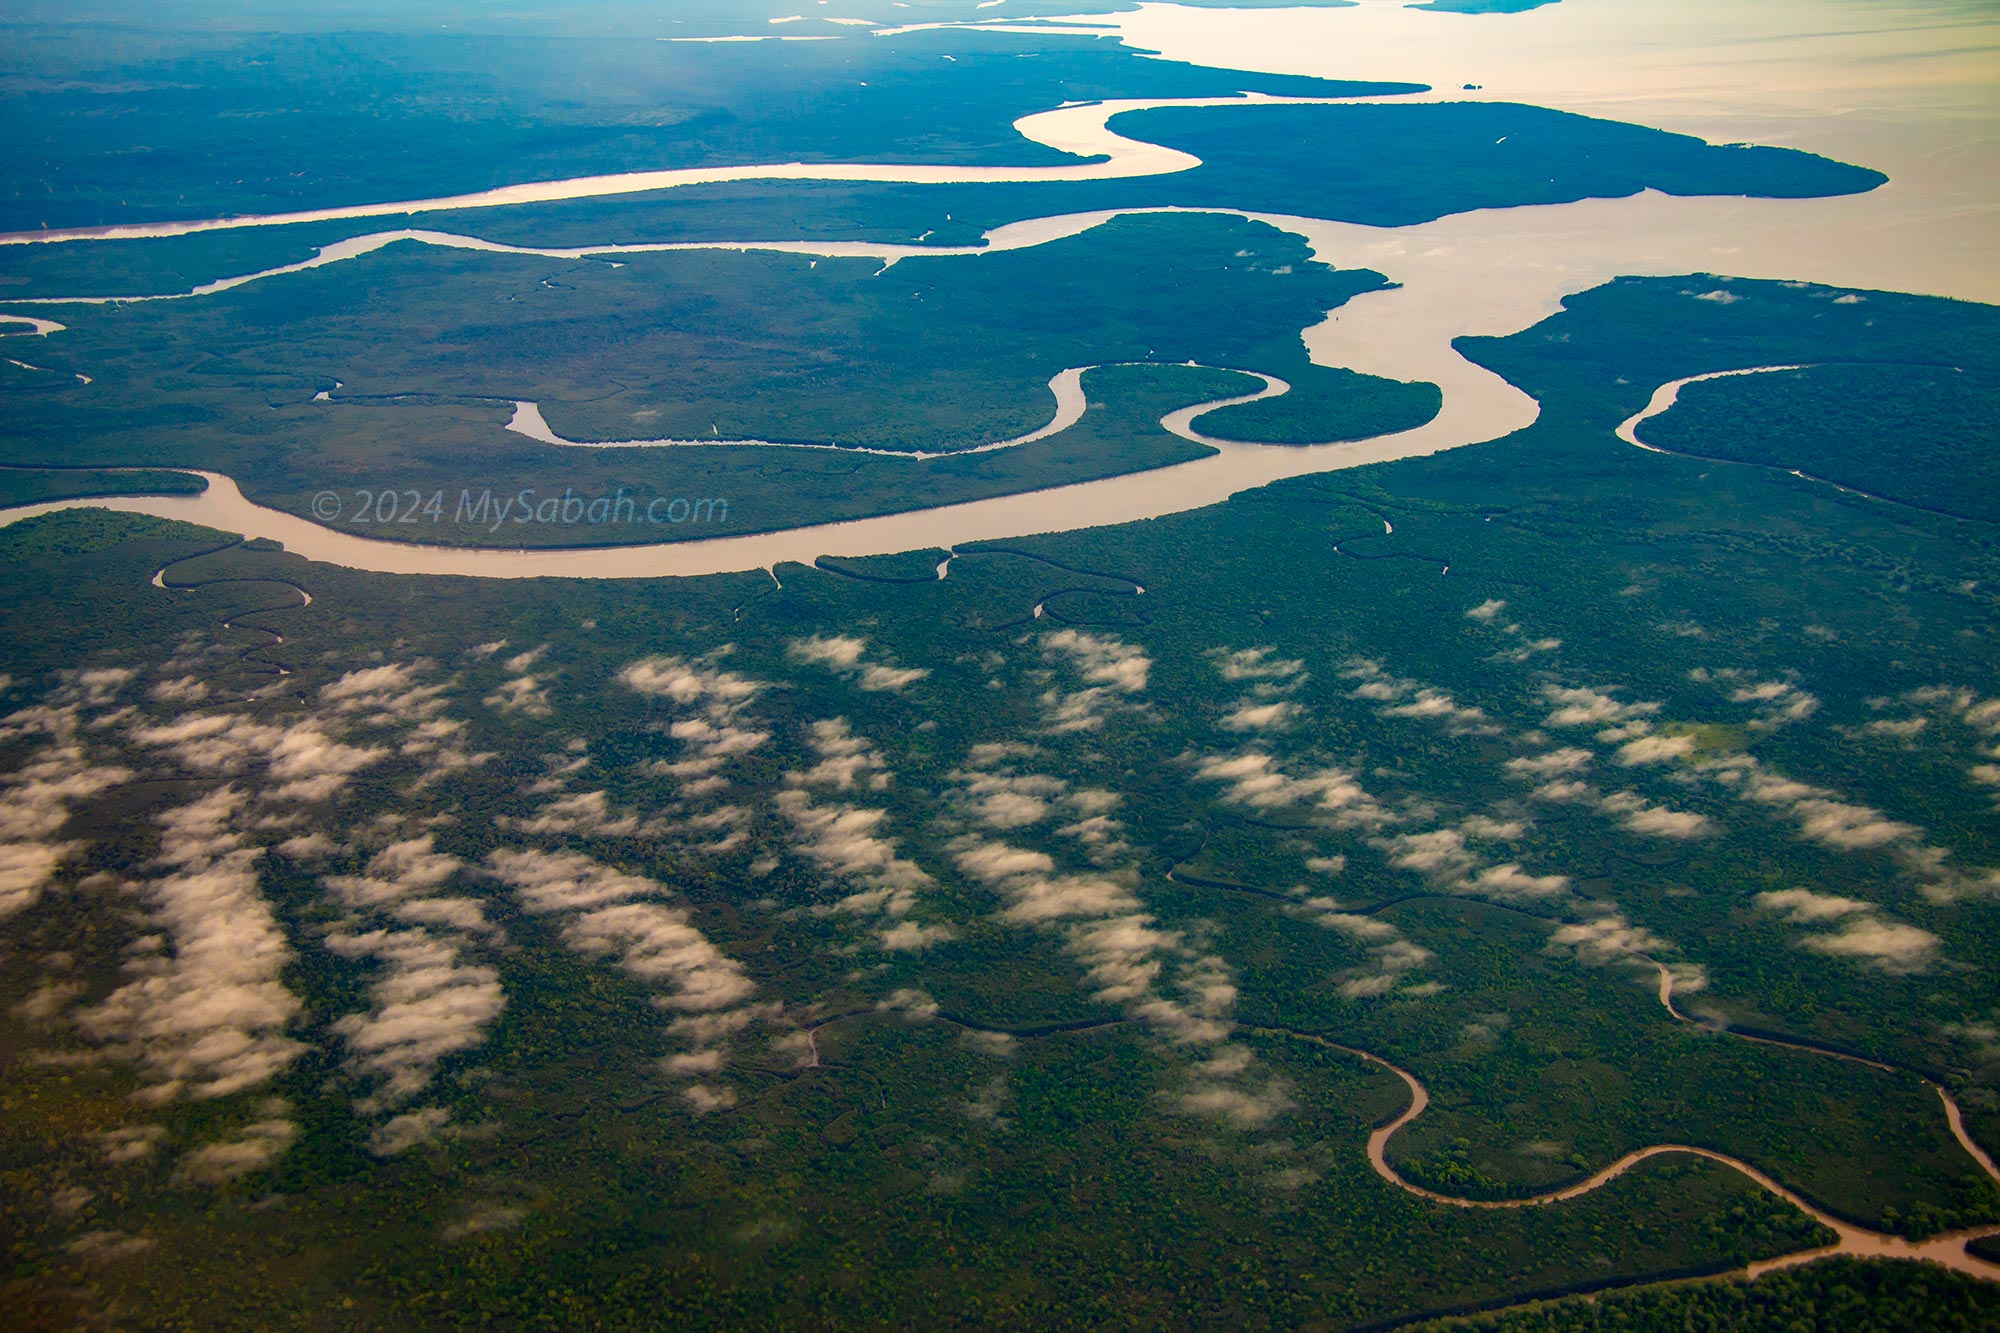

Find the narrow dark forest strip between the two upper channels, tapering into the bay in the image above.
[{"left": 0, "top": 102, "right": 1882, "bottom": 308}]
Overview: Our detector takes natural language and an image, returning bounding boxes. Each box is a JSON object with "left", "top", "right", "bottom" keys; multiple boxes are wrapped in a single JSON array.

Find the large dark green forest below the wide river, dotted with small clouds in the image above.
[{"left": 0, "top": 278, "right": 2000, "bottom": 1327}]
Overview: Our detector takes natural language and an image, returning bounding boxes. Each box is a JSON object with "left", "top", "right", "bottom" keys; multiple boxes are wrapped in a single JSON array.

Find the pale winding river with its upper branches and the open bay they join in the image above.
[{"left": 0, "top": 0, "right": 2000, "bottom": 578}]
